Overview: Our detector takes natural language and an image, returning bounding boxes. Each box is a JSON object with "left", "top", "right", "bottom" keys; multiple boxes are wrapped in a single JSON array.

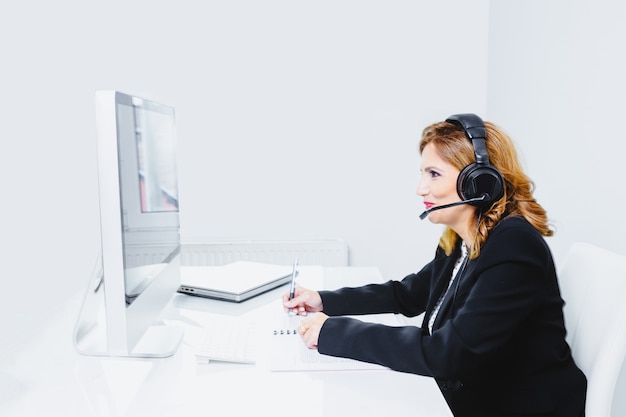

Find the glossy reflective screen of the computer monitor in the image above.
[{"left": 117, "top": 97, "right": 180, "bottom": 305}]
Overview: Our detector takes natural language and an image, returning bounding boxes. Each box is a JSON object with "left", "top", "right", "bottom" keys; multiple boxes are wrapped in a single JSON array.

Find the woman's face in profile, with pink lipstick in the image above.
[{"left": 417, "top": 143, "right": 475, "bottom": 231}]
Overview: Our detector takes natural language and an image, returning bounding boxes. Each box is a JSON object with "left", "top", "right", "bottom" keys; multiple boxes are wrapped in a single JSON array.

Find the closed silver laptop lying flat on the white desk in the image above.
[{"left": 178, "top": 261, "right": 292, "bottom": 302}]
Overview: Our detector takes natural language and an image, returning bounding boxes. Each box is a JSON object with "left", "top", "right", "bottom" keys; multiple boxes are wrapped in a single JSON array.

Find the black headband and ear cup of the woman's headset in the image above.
[{"left": 446, "top": 113, "right": 504, "bottom": 210}]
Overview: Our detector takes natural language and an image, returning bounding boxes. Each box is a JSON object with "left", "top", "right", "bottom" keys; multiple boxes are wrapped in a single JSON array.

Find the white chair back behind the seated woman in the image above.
[{"left": 559, "top": 243, "right": 626, "bottom": 417}]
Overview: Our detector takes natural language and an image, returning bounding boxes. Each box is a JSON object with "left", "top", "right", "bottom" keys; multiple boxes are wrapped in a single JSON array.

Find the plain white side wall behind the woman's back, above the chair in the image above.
[{"left": 488, "top": 0, "right": 626, "bottom": 261}]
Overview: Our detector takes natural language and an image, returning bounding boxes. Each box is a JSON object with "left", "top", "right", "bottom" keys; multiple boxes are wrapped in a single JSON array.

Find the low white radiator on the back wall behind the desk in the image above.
[{"left": 181, "top": 239, "right": 348, "bottom": 266}]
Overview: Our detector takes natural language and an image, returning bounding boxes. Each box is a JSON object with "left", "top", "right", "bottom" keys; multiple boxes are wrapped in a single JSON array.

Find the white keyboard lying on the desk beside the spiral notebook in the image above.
[{"left": 196, "top": 319, "right": 256, "bottom": 363}]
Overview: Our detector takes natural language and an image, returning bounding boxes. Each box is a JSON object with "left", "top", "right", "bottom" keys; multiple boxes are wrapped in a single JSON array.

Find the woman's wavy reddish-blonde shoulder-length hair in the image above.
[{"left": 419, "top": 121, "right": 554, "bottom": 259}]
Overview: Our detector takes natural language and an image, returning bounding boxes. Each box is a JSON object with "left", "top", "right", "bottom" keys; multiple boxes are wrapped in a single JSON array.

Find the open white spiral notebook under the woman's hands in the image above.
[{"left": 270, "top": 314, "right": 402, "bottom": 371}]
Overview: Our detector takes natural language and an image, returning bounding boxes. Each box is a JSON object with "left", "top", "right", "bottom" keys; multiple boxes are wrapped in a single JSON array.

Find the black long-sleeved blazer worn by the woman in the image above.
[{"left": 318, "top": 217, "right": 586, "bottom": 417}]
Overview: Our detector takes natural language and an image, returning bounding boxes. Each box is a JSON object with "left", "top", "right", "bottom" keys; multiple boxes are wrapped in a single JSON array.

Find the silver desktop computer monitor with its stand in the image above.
[{"left": 75, "top": 91, "right": 182, "bottom": 357}]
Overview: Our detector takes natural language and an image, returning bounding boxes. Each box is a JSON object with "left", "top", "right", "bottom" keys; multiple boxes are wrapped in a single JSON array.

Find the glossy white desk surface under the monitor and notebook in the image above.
[{"left": 0, "top": 268, "right": 451, "bottom": 417}]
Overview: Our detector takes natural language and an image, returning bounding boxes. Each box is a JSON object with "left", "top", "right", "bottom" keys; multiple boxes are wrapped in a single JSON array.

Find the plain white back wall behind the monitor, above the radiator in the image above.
[{"left": 0, "top": 0, "right": 488, "bottom": 351}]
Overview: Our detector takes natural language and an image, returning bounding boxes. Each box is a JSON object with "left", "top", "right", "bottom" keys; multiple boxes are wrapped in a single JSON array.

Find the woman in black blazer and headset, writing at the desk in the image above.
[{"left": 283, "top": 114, "right": 586, "bottom": 417}]
